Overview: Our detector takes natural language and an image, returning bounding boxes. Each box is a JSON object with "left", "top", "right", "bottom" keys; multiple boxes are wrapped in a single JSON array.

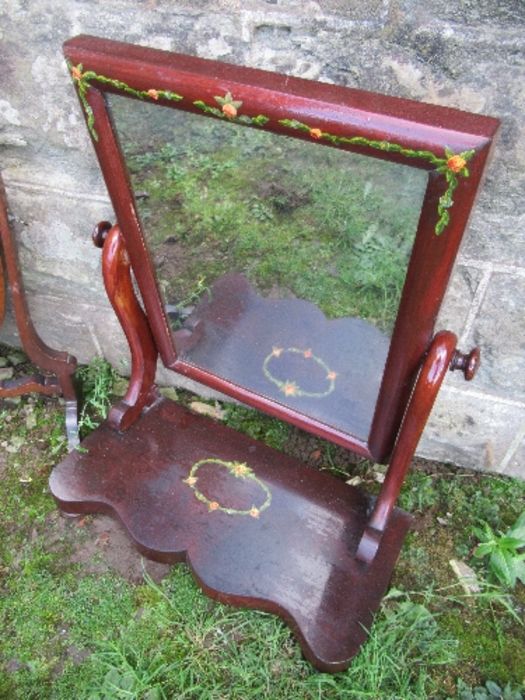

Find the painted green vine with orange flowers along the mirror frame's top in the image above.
[{"left": 68, "top": 63, "right": 475, "bottom": 236}]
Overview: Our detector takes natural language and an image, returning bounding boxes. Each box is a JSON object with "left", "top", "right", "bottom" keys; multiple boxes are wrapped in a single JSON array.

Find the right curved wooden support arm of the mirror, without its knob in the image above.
[{"left": 356, "top": 331, "right": 457, "bottom": 564}]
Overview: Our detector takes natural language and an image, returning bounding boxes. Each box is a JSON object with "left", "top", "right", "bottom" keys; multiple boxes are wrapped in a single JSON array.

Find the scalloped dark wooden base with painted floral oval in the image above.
[{"left": 50, "top": 399, "right": 411, "bottom": 672}]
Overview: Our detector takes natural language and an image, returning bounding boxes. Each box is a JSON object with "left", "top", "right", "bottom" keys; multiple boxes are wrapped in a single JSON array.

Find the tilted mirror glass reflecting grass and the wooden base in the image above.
[{"left": 108, "top": 95, "right": 427, "bottom": 440}]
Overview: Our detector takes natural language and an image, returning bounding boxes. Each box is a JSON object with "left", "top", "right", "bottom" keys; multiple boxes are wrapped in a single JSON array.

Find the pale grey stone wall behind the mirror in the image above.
[{"left": 0, "top": 0, "right": 525, "bottom": 477}]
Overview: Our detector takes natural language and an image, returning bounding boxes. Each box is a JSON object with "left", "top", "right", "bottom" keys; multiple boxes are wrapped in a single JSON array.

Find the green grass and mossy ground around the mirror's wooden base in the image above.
[{"left": 0, "top": 352, "right": 525, "bottom": 700}]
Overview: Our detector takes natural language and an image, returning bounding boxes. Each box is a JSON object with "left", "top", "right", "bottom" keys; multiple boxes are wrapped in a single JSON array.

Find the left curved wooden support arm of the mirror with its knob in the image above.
[{"left": 93, "top": 221, "right": 158, "bottom": 430}]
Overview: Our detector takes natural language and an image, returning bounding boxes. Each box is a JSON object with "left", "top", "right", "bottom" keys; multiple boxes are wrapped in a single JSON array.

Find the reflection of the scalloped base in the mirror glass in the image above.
[{"left": 175, "top": 274, "right": 390, "bottom": 442}]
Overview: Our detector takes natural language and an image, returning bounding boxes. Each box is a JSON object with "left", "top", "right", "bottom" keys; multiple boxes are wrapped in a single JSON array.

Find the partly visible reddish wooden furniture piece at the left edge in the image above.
[{"left": 0, "top": 176, "right": 78, "bottom": 447}]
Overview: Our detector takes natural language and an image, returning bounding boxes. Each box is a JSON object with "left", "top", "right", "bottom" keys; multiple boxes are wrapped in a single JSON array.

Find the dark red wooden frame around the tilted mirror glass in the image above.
[{"left": 64, "top": 36, "right": 499, "bottom": 462}]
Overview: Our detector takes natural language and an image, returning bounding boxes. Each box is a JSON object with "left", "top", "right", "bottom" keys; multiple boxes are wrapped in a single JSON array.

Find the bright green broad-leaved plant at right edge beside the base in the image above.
[{"left": 474, "top": 511, "right": 525, "bottom": 588}]
